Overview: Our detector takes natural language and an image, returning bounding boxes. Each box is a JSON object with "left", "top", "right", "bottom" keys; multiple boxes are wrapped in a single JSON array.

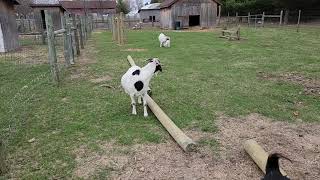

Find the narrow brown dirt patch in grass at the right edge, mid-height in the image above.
[{"left": 258, "top": 72, "right": 320, "bottom": 95}]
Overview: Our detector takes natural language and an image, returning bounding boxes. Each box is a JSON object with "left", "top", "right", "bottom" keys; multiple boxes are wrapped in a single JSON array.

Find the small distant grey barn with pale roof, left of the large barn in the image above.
[{"left": 138, "top": 3, "right": 161, "bottom": 22}]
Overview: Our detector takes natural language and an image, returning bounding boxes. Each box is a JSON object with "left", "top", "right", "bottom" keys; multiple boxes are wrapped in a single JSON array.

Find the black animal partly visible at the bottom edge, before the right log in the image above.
[{"left": 262, "top": 153, "right": 291, "bottom": 180}]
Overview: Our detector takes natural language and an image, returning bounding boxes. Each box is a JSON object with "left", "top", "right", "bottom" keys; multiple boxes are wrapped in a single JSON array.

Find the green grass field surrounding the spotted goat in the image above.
[{"left": 0, "top": 27, "right": 320, "bottom": 179}]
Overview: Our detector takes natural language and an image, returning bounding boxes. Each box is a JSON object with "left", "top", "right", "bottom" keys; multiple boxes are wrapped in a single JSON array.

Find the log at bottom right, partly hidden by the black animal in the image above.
[{"left": 244, "top": 139, "right": 287, "bottom": 176}]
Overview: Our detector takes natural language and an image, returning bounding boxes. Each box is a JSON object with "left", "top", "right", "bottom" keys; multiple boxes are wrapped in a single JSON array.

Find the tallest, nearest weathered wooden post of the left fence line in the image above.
[{"left": 44, "top": 10, "right": 60, "bottom": 83}]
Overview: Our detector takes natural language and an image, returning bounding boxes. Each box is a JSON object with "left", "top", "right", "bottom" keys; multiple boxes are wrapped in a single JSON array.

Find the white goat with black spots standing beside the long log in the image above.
[{"left": 121, "top": 58, "right": 162, "bottom": 117}]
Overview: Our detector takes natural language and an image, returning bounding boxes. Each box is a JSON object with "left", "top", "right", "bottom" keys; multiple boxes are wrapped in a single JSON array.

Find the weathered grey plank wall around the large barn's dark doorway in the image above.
[{"left": 161, "top": 0, "right": 217, "bottom": 29}]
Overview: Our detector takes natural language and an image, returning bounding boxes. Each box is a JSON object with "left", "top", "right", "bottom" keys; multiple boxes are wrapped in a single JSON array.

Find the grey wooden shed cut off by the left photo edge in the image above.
[{"left": 0, "top": 0, "right": 19, "bottom": 53}]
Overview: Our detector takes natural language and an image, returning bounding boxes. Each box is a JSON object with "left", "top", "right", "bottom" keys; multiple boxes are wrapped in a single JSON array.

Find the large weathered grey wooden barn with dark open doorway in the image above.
[{"left": 160, "top": 0, "right": 221, "bottom": 29}]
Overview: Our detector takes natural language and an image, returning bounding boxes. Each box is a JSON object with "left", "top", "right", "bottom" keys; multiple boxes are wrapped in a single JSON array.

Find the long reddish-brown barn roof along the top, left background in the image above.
[{"left": 60, "top": 1, "right": 116, "bottom": 9}]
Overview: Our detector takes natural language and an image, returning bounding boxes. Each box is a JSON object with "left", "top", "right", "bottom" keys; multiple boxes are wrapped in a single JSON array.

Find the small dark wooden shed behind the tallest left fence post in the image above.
[{"left": 30, "top": 0, "right": 65, "bottom": 32}]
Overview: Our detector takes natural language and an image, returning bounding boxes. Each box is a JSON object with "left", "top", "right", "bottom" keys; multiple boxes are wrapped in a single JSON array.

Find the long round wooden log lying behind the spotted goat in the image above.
[{"left": 127, "top": 56, "right": 196, "bottom": 152}]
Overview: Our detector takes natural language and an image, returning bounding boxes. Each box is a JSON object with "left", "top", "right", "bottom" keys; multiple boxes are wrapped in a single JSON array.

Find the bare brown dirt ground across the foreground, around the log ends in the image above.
[{"left": 74, "top": 114, "right": 320, "bottom": 180}]
